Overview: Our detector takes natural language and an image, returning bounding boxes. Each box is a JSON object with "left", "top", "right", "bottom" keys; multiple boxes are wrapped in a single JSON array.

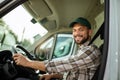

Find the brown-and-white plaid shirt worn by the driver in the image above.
[{"left": 46, "top": 42, "right": 101, "bottom": 80}]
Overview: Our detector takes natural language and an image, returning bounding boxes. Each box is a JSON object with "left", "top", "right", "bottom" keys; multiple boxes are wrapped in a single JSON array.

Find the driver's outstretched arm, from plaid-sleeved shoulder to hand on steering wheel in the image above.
[{"left": 13, "top": 47, "right": 100, "bottom": 73}]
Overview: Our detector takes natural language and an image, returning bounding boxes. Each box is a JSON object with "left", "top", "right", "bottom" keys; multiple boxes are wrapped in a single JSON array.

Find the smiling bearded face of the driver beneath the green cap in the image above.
[{"left": 73, "top": 24, "right": 91, "bottom": 45}]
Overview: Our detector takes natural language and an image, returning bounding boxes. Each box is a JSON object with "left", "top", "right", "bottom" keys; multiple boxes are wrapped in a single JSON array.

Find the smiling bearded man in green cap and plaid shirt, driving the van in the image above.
[{"left": 13, "top": 17, "right": 101, "bottom": 80}]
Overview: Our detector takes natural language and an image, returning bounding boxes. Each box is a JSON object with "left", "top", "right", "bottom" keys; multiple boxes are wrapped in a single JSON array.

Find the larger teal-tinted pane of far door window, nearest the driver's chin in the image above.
[{"left": 53, "top": 34, "right": 73, "bottom": 58}]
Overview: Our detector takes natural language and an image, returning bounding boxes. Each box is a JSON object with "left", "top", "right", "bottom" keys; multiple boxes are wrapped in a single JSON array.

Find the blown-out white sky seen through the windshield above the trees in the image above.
[{"left": 3, "top": 6, "right": 47, "bottom": 41}]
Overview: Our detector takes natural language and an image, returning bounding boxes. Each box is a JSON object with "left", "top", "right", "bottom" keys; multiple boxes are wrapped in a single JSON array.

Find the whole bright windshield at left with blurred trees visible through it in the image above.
[{"left": 0, "top": 6, "right": 47, "bottom": 49}]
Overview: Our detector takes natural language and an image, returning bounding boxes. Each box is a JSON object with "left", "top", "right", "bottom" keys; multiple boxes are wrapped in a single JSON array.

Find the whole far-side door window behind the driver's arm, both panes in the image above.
[{"left": 36, "top": 34, "right": 74, "bottom": 60}]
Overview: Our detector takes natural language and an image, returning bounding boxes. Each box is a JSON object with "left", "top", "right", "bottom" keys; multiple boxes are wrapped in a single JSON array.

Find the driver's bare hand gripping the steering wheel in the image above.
[{"left": 13, "top": 54, "right": 30, "bottom": 66}]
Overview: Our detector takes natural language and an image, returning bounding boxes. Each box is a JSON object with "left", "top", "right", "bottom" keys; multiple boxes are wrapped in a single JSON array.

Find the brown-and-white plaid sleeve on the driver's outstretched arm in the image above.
[{"left": 46, "top": 46, "right": 100, "bottom": 73}]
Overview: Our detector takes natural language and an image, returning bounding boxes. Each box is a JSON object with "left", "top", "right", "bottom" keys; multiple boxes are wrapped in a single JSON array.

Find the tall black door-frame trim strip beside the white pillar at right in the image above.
[{"left": 98, "top": 0, "right": 110, "bottom": 80}]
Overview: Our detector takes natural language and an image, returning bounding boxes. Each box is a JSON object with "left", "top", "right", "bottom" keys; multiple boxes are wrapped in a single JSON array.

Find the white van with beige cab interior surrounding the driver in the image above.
[{"left": 0, "top": 0, "right": 120, "bottom": 80}]
